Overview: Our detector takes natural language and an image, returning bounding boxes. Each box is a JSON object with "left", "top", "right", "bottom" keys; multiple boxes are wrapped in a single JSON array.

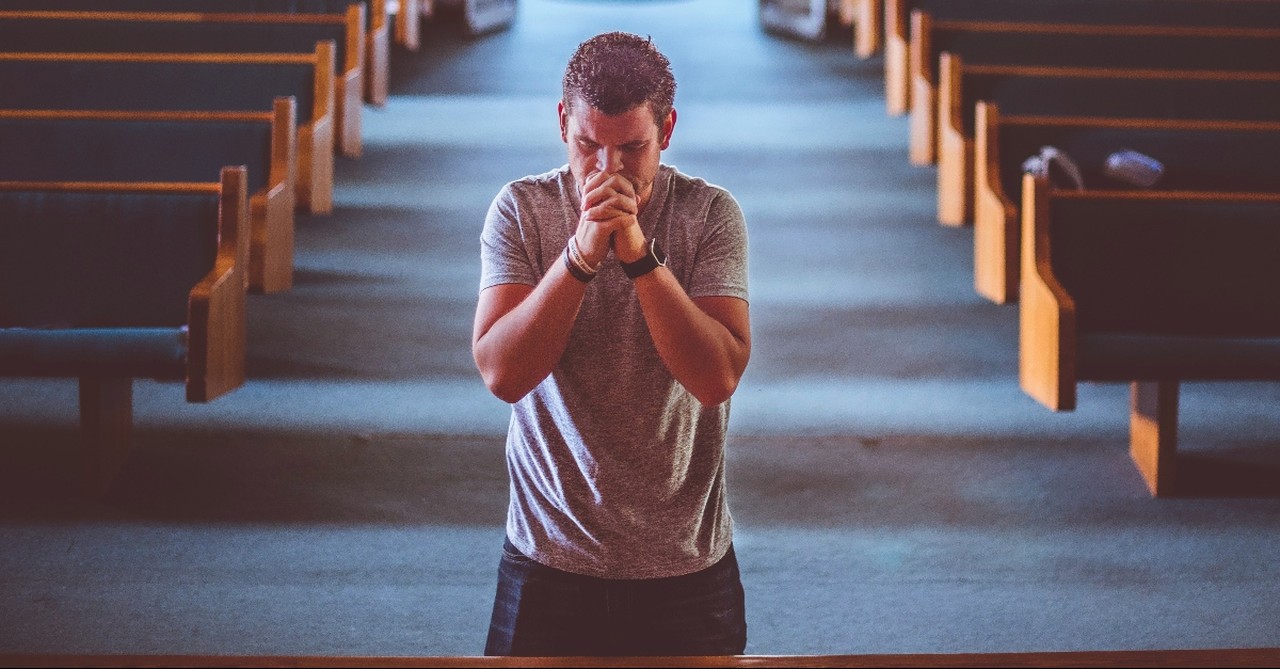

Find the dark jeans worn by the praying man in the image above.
[{"left": 484, "top": 540, "right": 746, "bottom": 656}]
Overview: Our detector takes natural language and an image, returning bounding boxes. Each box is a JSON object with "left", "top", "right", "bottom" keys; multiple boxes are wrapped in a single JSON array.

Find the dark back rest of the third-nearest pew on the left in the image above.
[{"left": 0, "top": 54, "right": 329, "bottom": 125}]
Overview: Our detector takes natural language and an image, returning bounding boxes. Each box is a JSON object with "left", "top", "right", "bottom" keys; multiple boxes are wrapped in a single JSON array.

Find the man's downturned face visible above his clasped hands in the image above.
[{"left": 559, "top": 98, "right": 676, "bottom": 207}]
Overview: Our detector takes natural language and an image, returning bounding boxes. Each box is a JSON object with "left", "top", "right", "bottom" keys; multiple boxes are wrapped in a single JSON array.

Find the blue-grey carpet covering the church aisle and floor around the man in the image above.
[{"left": 0, "top": 0, "right": 1280, "bottom": 655}]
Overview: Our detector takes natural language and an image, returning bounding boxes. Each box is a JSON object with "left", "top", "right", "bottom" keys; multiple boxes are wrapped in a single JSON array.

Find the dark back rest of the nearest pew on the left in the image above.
[{"left": 0, "top": 189, "right": 219, "bottom": 329}]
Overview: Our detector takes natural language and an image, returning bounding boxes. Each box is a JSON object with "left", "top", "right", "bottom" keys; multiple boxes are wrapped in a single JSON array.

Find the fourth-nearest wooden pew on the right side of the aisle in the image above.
[{"left": 909, "top": 12, "right": 1280, "bottom": 165}]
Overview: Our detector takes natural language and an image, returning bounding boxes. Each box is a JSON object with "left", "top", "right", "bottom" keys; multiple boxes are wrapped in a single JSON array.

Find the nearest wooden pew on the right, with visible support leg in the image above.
[{"left": 1019, "top": 175, "right": 1280, "bottom": 496}]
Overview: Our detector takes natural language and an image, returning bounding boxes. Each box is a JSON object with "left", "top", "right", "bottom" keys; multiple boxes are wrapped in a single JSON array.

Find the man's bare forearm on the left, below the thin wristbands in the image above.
[{"left": 472, "top": 257, "right": 586, "bottom": 403}]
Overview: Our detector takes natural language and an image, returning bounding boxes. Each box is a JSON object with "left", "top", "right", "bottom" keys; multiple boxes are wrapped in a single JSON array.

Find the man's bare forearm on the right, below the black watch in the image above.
[{"left": 635, "top": 267, "right": 751, "bottom": 407}]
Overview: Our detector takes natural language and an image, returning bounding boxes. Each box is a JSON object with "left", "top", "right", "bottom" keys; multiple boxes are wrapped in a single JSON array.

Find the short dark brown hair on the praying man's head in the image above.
[{"left": 562, "top": 32, "right": 676, "bottom": 128}]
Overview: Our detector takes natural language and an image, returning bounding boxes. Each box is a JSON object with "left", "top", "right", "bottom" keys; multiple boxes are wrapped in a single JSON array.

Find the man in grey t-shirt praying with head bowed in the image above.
[{"left": 472, "top": 32, "right": 751, "bottom": 655}]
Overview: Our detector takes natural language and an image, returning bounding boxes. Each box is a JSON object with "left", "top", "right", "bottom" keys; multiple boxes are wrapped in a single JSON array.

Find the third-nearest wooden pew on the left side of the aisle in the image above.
[{"left": 0, "top": 42, "right": 334, "bottom": 214}]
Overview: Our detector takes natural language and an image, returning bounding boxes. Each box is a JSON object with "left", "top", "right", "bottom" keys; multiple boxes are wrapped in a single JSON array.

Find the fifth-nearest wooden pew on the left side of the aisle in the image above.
[{"left": 0, "top": 0, "right": 389, "bottom": 106}]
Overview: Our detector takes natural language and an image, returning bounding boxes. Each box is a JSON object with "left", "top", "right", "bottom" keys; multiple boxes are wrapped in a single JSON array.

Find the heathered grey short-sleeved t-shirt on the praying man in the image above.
[{"left": 480, "top": 165, "right": 748, "bottom": 578}]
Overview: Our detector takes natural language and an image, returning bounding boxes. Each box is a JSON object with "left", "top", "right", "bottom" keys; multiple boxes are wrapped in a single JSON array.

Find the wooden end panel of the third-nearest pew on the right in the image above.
[{"left": 937, "top": 51, "right": 973, "bottom": 228}]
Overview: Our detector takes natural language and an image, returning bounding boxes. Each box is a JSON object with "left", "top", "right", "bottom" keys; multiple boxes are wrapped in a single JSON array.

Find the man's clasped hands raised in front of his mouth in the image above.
[{"left": 573, "top": 171, "right": 645, "bottom": 267}]
